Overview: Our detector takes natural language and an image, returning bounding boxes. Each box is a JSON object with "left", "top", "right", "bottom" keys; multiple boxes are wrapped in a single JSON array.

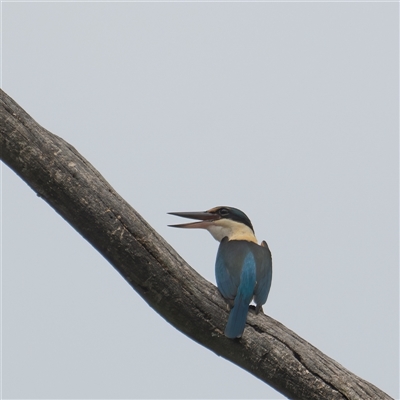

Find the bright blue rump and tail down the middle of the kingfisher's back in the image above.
[{"left": 225, "top": 253, "right": 256, "bottom": 339}]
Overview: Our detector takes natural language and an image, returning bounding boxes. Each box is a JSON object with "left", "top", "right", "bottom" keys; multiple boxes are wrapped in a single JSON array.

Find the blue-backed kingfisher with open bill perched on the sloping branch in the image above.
[{"left": 169, "top": 206, "right": 272, "bottom": 339}]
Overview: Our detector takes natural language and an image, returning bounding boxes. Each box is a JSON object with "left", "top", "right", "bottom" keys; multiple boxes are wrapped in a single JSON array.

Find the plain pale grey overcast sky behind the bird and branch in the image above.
[{"left": 2, "top": 2, "right": 399, "bottom": 399}]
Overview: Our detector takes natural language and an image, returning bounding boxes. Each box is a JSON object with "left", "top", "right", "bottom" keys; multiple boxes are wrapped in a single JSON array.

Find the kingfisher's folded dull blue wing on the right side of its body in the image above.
[{"left": 254, "top": 241, "right": 272, "bottom": 309}]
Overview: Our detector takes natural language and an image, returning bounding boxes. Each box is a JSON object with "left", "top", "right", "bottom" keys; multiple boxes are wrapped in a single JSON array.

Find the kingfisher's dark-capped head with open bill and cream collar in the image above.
[{"left": 168, "top": 206, "right": 257, "bottom": 243}]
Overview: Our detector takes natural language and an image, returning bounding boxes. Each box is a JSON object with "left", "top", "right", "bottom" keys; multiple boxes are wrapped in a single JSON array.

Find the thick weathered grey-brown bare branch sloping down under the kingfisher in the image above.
[{"left": 0, "top": 92, "right": 391, "bottom": 400}]
